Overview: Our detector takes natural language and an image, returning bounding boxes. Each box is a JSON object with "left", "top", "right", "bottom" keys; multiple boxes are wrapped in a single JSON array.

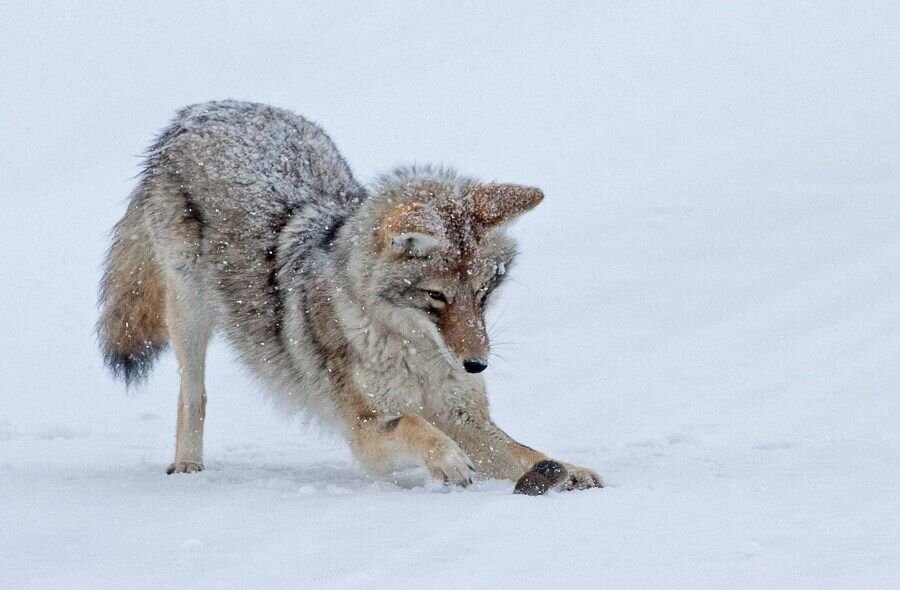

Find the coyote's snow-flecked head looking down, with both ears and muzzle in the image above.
[{"left": 346, "top": 168, "right": 543, "bottom": 373}]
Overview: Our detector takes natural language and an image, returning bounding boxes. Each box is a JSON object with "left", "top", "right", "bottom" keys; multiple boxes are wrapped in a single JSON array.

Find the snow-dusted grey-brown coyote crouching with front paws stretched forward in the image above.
[{"left": 98, "top": 101, "right": 602, "bottom": 493}]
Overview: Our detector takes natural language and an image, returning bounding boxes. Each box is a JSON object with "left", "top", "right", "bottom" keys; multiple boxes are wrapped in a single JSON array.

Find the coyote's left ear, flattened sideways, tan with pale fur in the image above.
[{"left": 375, "top": 203, "right": 447, "bottom": 257}]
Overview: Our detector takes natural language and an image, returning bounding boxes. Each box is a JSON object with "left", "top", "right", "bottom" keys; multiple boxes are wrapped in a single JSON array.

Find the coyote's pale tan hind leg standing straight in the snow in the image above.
[{"left": 166, "top": 279, "right": 212, "bottom": 474}]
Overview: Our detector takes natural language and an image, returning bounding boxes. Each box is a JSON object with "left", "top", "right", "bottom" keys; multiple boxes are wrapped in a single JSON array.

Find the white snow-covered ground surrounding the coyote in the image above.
[{"left": 0, "top": 2, "right": 900, "bottom": 588}]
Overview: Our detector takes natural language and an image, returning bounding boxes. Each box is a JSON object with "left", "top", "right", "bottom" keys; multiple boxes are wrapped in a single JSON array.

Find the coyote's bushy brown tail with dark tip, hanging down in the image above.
[{"left": 97, "top": 187, "right": 168, "bottom": 385}]
